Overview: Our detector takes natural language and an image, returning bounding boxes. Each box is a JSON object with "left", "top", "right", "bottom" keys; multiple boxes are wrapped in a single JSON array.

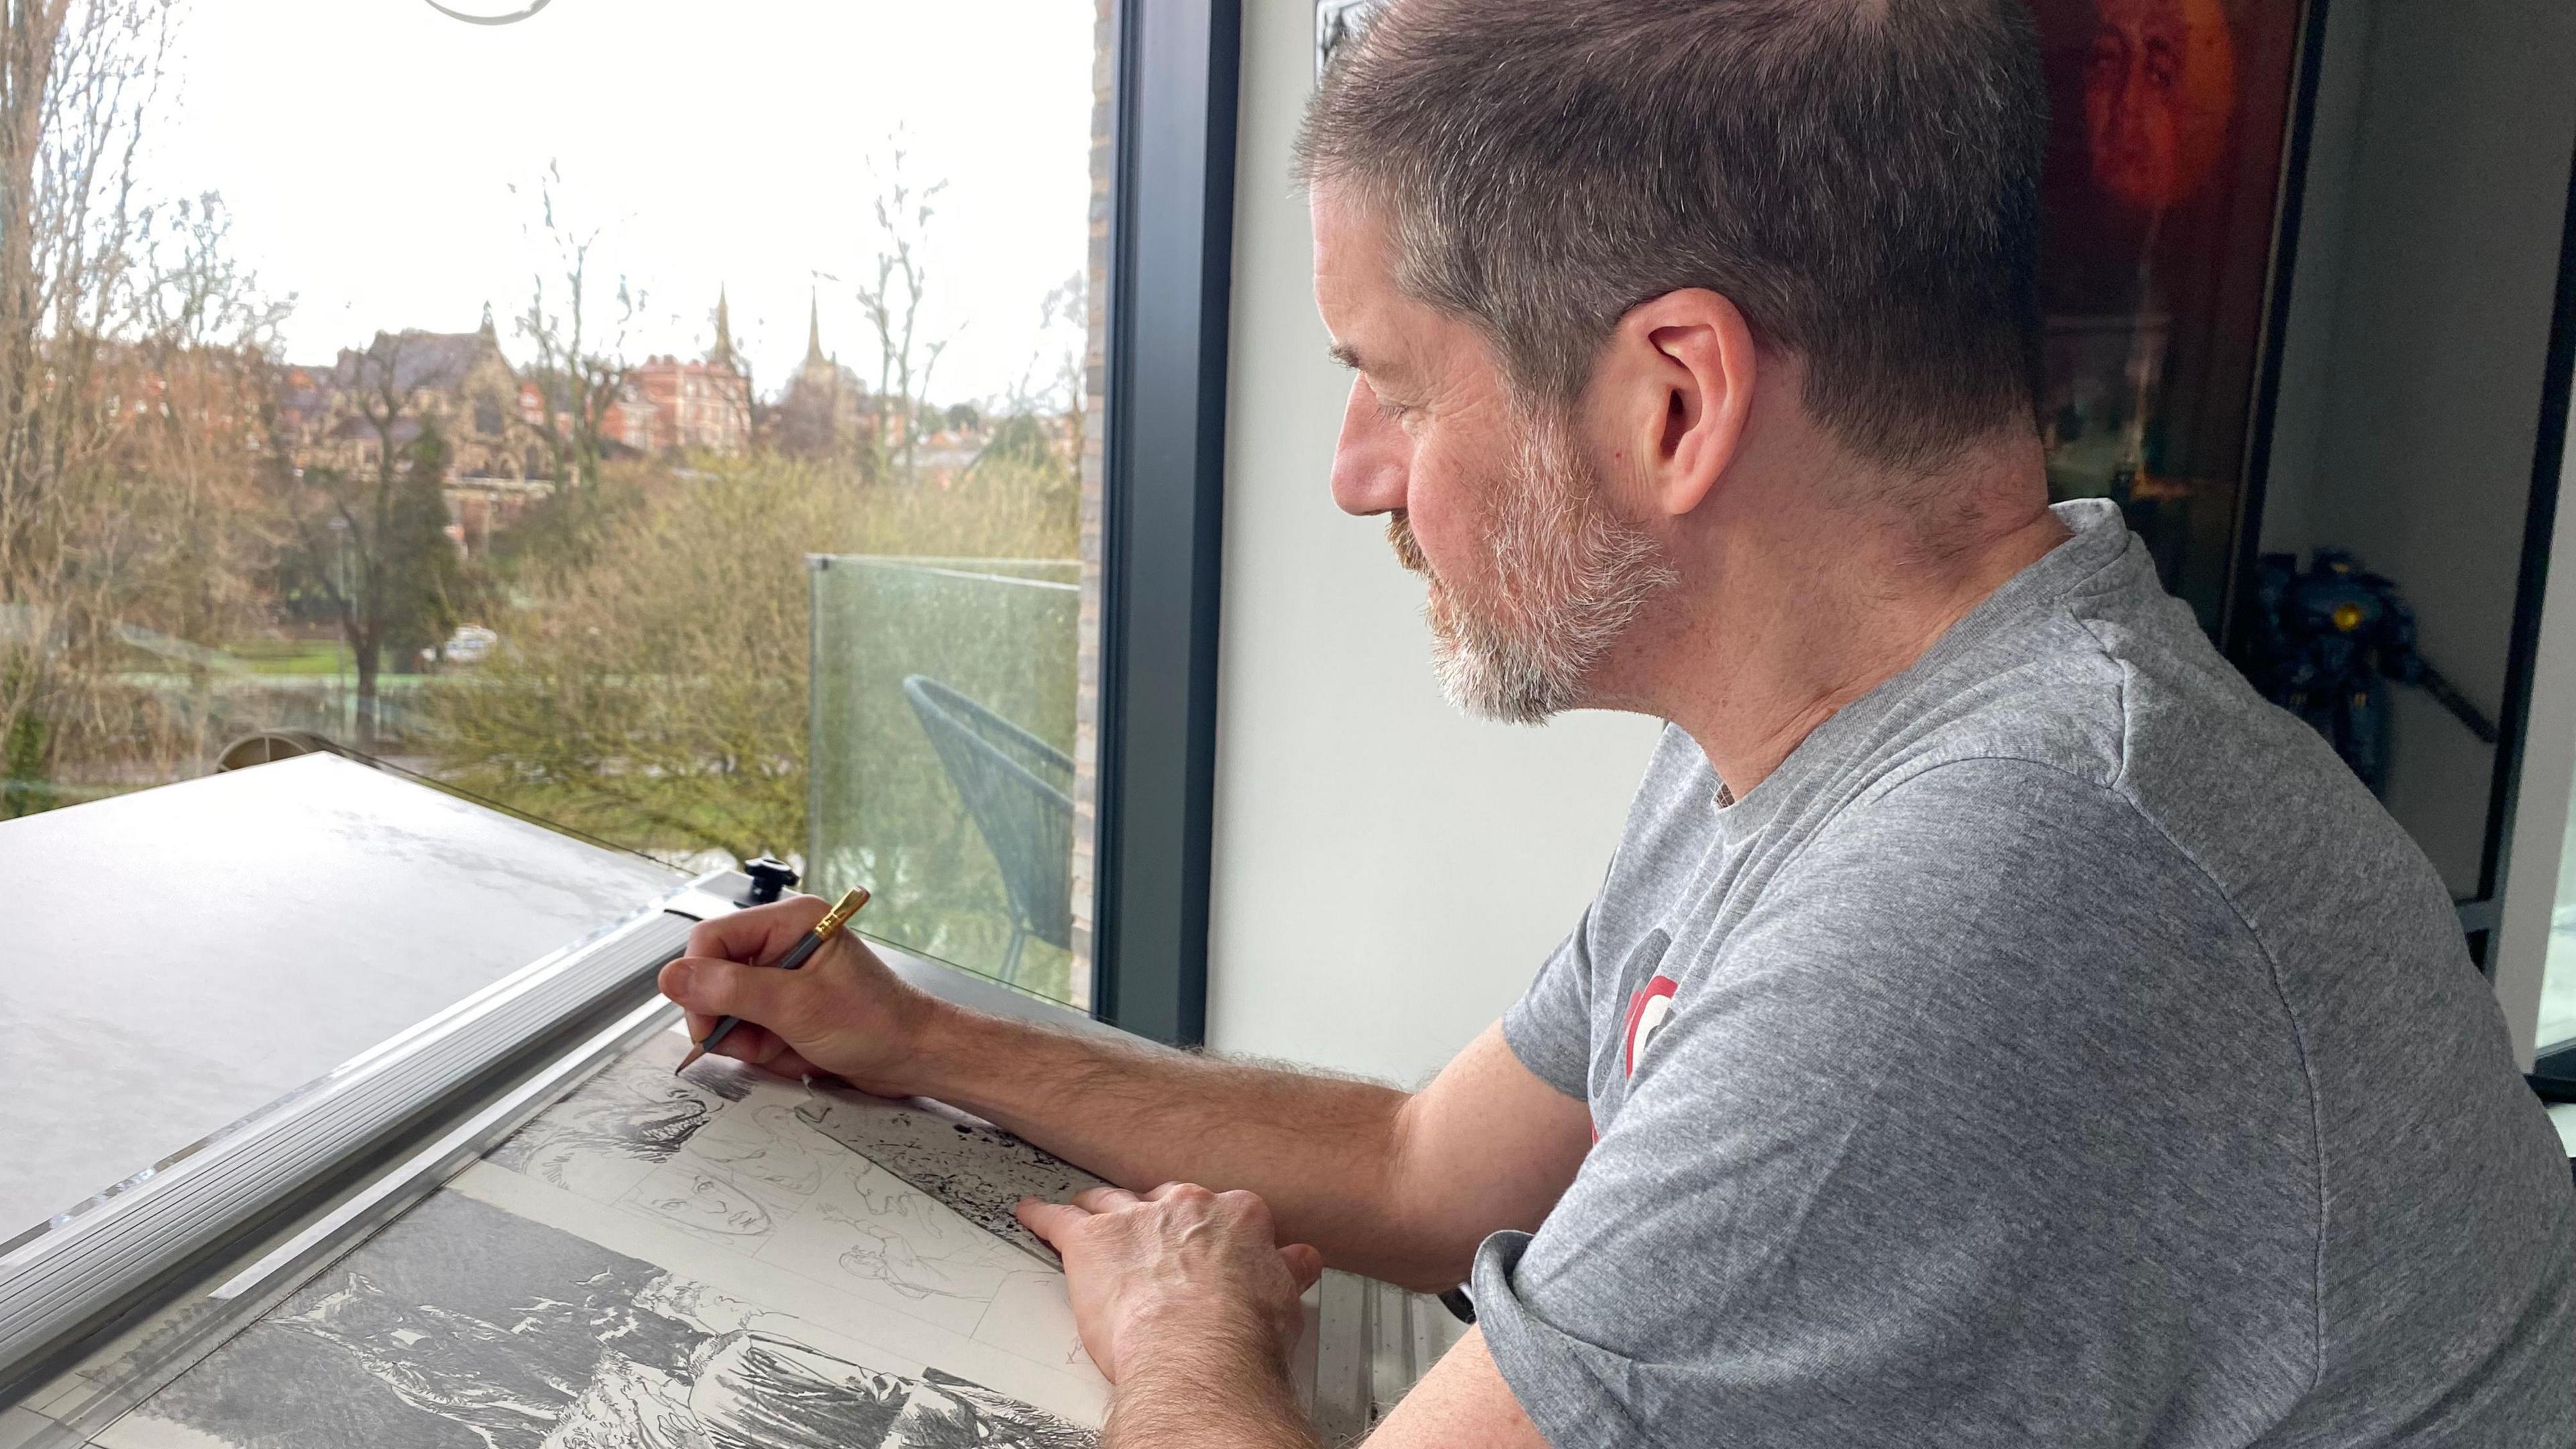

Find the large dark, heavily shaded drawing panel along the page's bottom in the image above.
[{"left": 98, "top": 1191, "right": 1097, "bottom": 1449}]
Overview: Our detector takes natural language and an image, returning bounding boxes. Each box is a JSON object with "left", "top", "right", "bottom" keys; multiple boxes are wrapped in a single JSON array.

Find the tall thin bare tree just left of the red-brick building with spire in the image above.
[{"left": 513, "top": 162, "right": 644, "bottom": 490}]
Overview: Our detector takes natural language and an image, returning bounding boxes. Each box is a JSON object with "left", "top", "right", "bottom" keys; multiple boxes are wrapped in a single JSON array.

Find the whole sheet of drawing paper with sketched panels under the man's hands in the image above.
[{"left": 78, "top": 1016, "right": 1108, "bottom": 1449}]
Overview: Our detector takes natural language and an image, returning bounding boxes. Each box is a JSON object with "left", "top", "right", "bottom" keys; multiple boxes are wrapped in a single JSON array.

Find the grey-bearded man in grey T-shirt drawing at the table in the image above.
[{"left": 662, "top": 0, "right": 2576, "bottom": 1449}]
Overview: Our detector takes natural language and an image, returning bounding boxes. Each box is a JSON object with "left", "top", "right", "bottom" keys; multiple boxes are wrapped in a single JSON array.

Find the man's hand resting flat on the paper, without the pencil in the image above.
[{"left": 1020, "top": 1183, "right": 1324, "bottom": 1385}]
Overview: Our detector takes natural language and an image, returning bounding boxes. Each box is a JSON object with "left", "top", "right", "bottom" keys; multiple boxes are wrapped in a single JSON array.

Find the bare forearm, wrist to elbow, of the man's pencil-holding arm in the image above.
[{"left": 917, "top": 1011, "right": 1473, "bottom": 1281}]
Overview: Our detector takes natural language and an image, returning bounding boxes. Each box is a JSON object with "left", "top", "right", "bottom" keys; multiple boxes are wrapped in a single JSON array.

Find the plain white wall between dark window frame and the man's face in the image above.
[{"left": 1208, "top": 0, "right": 1656, "bottom": 1083}]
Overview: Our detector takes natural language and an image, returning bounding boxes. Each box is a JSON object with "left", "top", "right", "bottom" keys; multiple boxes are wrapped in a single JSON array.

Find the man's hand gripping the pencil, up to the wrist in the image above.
[{"left": 659, "top": 895, "right": 945, "bottom": 1095}]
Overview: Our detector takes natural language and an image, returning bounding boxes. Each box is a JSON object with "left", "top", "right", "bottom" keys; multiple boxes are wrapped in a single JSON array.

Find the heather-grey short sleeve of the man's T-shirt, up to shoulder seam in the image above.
[{"left": 1473, "top": 763, "right": 2316, "bottom": 1449}]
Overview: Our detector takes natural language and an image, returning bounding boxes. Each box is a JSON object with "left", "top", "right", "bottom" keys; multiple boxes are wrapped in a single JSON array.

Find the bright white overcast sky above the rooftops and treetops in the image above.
[{"left": 144, "top": 0, "right": 1095, "bottom": 402}]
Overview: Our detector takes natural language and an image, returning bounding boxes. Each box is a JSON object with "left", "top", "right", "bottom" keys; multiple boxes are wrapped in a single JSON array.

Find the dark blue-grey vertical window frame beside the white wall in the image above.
[{"left": 1092, "top": 0, "right": 1242, "bottom": 1046}]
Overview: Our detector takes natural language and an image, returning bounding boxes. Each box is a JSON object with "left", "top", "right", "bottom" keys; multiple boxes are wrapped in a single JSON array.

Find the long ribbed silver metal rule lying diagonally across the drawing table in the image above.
[{"left": 0, "top": 902, "right": 696, "bottom": 1403}]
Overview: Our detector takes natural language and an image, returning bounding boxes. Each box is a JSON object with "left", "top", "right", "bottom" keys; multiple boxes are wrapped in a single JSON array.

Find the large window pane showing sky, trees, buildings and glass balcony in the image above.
[{"left": 0, "top": 0, "right": 1110, "bottom": 1003}]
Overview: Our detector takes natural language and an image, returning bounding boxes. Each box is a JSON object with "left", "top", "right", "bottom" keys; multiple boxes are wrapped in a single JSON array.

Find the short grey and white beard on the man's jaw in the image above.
[{"left": 1386, "top": 412, "right": 1677, "bottom": 724}]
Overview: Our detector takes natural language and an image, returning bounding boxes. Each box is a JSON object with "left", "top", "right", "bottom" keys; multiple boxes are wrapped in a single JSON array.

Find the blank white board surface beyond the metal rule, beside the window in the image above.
[{"left": 0, "top": 755, "right": 685, "bottom": 1240}]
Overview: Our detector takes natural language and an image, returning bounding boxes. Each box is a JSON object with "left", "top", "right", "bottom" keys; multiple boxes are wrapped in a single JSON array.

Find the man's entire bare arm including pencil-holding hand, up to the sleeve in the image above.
[{"left": 662, "top": 898, "right": 1592, "bottom": 1292}]
